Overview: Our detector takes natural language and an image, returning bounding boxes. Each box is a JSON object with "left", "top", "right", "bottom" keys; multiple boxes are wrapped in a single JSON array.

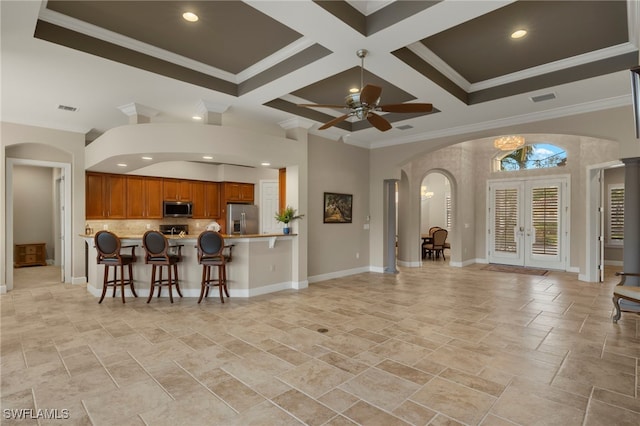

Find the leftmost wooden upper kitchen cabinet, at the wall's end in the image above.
[{"left": 85, "top": 172, "right": 127, "bottom": 219}]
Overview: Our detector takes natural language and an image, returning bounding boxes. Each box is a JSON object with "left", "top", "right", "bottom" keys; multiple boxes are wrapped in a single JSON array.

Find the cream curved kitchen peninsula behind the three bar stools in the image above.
[{"left": 81, "top": 234, "right": 297, "bottom": 303}]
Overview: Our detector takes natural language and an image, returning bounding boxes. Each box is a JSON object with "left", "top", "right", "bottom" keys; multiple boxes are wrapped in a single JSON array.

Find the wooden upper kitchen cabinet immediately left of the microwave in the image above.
[{"left": 127, "top": 176, "right": 163, "bottom": 219}]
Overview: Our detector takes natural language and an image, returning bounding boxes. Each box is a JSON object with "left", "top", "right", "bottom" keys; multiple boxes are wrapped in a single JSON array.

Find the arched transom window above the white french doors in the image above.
[{"left": 497, "top": 143, "right": 567, "bottom": 171}]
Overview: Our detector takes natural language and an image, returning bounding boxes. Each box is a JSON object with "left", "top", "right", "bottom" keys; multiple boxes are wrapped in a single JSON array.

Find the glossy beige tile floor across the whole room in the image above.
[{"left": 0, "top": 261, "right": 640, "bottom": 426}]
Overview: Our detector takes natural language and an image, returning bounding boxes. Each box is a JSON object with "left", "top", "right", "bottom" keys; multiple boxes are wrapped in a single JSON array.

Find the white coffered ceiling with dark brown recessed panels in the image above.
[{"left": 1, "top": 0, "right": 640, "bottom": 148}]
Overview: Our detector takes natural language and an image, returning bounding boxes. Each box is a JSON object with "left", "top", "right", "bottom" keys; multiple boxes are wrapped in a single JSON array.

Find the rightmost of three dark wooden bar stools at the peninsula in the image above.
[{"left": 196, "top": 231, "right": 233, "bottom": 303}]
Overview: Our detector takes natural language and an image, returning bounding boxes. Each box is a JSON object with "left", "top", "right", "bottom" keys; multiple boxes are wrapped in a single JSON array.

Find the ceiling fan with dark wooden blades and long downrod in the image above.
[{"left": 298, "top": 49, "right": 433, "bottom": 132}]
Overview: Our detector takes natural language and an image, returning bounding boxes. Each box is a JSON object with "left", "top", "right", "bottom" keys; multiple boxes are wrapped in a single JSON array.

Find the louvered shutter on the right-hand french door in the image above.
[{"left": 531, "top": 186, "right": 560, "bottom": 256}]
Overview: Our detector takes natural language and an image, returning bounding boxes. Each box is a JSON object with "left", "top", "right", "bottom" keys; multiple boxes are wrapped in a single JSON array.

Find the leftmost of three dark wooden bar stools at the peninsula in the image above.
[{"left": 94, "top": 231, "right": 138, "bottom": 303}]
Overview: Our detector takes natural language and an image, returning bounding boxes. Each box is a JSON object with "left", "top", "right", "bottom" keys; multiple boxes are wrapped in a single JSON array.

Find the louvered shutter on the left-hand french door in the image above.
[{"left": 493, "top": 188, "right": 518, "bottom": 253}]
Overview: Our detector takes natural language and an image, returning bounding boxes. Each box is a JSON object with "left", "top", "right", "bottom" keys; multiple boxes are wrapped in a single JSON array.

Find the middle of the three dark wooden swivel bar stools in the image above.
[{"left": 142, "top": 231, "right": 183, "bottom": 303}]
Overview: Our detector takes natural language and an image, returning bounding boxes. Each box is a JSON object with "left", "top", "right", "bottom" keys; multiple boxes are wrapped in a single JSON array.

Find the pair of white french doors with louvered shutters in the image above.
[{"left": 487, "top": 177, "right": 568, "bottom": 270}]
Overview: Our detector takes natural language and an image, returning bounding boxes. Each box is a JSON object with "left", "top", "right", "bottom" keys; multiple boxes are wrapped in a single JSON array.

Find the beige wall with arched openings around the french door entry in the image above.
[{"left": 369, "top": 105, "right": 640, "bottom": 271}]
